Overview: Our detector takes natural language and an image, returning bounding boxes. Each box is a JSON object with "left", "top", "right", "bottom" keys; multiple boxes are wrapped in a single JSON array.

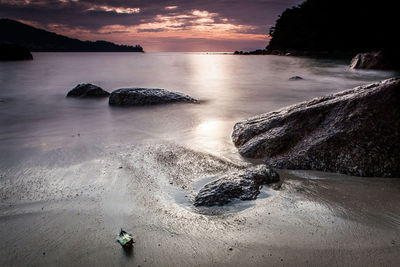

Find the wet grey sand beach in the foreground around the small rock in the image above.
[{"left": 0, "top": 141, "right": 400, "bottom": 266}]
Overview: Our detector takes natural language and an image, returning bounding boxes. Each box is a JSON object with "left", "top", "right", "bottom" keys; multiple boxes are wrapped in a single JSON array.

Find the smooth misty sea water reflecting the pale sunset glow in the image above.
[{"left": 0, "top": 53, "right": 394, "bottom": 167}]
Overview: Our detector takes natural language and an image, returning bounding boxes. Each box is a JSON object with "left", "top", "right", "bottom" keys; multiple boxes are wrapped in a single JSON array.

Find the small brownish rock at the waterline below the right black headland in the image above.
[{"left": 350, "top": 52, "right": 394, "bottom": 70}]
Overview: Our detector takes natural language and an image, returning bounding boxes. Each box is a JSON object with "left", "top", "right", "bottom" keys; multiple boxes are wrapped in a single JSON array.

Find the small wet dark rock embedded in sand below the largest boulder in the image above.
[{"left": 194, "top": 165, "right": 279, "bottom": 206}]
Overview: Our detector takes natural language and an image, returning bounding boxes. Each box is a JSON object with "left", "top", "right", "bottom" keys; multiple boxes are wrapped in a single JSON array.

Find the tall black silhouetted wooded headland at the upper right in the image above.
[{"left": 266, "top": 0, "right": 400, "bottom": 59}]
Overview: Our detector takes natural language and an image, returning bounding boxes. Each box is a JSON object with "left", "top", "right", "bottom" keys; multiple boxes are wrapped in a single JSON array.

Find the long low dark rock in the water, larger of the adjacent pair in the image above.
[{"left": 109, "top": 88, "right": 197, "bottom": 106}]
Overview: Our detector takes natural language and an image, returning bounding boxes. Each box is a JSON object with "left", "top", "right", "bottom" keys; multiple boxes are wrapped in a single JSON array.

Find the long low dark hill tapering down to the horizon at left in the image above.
[{"left": 0, "top": 19, "right": 143, "bottom": 52}]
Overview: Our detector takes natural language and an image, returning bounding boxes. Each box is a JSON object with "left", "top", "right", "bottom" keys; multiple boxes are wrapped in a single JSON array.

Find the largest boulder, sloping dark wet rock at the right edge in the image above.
[{"left": 232, "top": 78, "right": 400, "bottom": 177}]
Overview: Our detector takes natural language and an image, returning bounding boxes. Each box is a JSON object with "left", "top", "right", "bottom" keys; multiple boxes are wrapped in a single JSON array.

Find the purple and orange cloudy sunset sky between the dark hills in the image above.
[{"left": 0, "top": 0, "right": 303, "bottom": 52}]
